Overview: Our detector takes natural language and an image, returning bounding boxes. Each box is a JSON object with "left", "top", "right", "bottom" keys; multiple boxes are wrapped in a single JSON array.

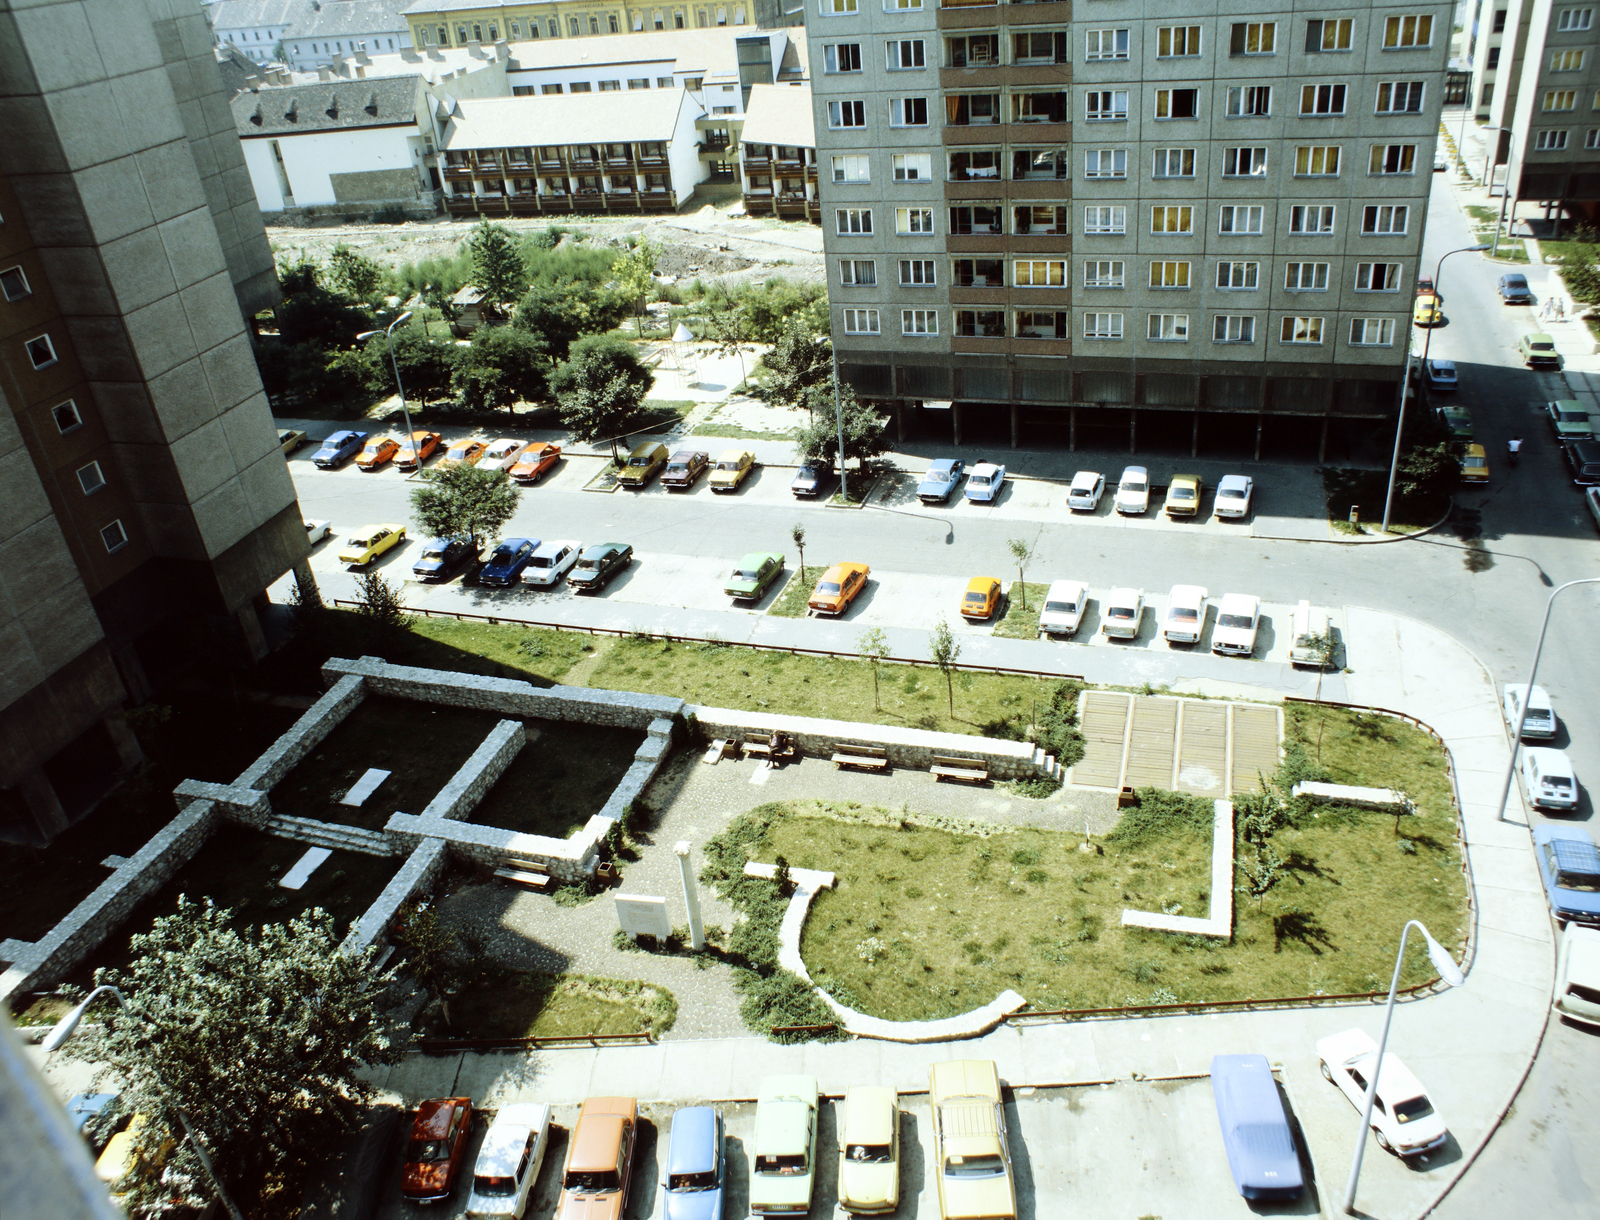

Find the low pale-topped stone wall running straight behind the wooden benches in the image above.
[{"left": 686, "top": 708, "right": 1058, "bottom": 780}]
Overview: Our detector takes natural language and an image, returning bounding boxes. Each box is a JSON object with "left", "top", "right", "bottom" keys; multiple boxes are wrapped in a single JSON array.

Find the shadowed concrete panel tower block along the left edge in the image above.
[{"left": 0, "top": 0, "right": 307, "bottom": 837}]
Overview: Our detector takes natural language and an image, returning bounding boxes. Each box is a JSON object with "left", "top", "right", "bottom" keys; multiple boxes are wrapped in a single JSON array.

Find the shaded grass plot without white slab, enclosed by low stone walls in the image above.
[{"left": 472, "top": 720, "right": 645, "bottom": 839}]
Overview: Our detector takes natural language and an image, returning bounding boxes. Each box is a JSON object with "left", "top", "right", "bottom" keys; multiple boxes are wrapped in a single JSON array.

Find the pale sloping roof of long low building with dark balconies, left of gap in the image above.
[{"left": 442, "top": 90, "right": 688, "bottom": 149}]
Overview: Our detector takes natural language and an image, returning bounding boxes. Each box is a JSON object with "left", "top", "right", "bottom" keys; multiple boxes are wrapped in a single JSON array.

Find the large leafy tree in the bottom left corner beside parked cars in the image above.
[{"left": 66, "top": 897, "right": 403, "bottom": 1215}]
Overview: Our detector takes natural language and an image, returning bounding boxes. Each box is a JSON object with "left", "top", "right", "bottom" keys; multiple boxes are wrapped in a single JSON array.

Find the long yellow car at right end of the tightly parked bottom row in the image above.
[{"left": 928, "top": 1058, "right": 1016, "bottom": 1220}]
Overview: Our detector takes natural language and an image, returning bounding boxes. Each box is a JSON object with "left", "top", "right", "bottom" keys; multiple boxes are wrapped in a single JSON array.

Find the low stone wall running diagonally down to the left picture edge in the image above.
[{"left": 0, "top": 801, "right": 221, "bottom": 1001}]
